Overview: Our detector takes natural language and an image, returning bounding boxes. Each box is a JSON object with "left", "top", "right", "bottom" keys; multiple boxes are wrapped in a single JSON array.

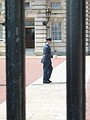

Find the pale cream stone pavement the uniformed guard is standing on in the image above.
[{"left": 0, "top": 57, "right": 90, "bottom": 120}]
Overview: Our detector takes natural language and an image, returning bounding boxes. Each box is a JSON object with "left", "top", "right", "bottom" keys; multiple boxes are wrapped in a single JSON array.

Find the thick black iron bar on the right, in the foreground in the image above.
[{"left": 66, "top": 0, "right": 86, "bottom": 120}]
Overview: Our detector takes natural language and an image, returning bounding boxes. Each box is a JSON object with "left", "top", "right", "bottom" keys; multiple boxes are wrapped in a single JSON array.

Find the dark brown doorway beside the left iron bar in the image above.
[{"left": 25, "top": 28, "right": 35, "bottom": 49}]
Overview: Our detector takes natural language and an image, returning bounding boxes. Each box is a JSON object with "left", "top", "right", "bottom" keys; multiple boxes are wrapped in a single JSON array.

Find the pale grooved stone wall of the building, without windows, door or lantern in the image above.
[{"left": 0, "top": 0, "right": 90, "bottom": 55}]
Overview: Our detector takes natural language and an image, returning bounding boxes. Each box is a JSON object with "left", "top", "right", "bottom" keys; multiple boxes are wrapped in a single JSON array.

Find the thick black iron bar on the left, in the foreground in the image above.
[{"left": 5, "top": 0, "right": 25, "bottom": 120}]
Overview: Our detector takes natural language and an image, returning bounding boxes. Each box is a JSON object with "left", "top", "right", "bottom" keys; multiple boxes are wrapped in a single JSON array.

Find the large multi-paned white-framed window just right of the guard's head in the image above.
[{"left": 51, "top": 22, "right": 61, "bottom": 40}]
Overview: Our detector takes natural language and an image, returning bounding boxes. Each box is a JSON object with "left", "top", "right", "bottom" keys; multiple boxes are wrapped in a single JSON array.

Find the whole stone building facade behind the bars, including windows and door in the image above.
[{"left": 0, "top": 0, "right": 90, "bottom": 55}]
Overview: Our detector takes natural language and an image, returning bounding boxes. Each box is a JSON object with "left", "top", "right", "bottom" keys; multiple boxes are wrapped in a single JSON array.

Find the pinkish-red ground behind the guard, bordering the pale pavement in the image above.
[{"left": 0, "top": 58, "right": 65, "bottom": 104}]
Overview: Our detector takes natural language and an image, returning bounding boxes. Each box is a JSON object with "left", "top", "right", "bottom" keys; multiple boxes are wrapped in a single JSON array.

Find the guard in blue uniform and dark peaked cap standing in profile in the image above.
[{"left": 41, "top": 38, "right": 53, "bottom": 83}]
